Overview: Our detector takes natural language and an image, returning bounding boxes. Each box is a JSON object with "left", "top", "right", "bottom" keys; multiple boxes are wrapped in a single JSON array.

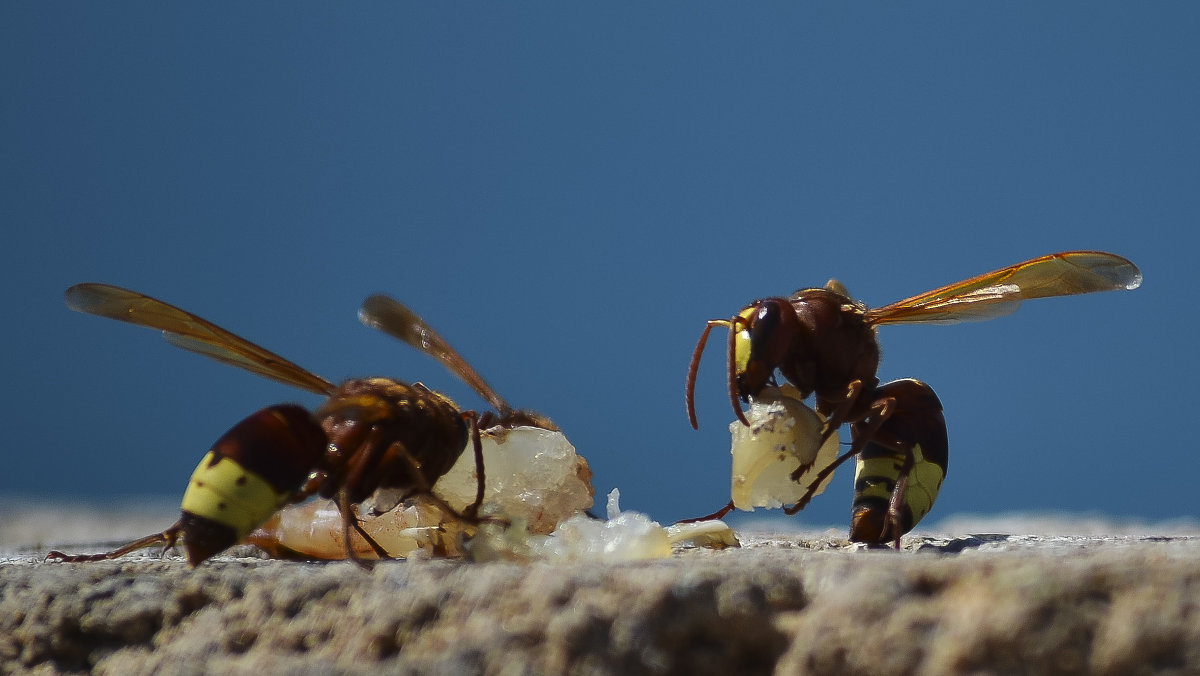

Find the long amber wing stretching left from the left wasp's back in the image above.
[{"left": 66, "top": 283, "right": 335, "bottom": 395}]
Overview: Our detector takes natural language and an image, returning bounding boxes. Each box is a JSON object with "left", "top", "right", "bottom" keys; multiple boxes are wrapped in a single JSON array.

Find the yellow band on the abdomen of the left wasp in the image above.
[{"left": 181, "top": 451, "right": 292, "bottom": 539}]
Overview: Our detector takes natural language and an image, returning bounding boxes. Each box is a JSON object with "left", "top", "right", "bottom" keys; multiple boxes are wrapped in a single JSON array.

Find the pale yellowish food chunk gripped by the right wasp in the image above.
[{"left": 730, "top": 385, "right": 839, "bottom": 512}]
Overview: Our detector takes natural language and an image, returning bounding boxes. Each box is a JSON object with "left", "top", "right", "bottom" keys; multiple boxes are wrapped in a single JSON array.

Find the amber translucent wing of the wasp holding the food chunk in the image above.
[{"left": 866, "top": 251, "right": 1141, "bottom": 324}]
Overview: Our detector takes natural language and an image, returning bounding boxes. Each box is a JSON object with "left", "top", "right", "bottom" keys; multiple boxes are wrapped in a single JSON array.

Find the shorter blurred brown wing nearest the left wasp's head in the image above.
[{"left": 359, "top": 294, "right": 512, "bottom": 417}]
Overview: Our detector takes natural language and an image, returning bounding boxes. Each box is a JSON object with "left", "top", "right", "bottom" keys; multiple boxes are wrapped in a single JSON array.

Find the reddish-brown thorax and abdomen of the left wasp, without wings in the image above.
[{"left": 175, "top": 378, "right": 473, "bottom": 566}]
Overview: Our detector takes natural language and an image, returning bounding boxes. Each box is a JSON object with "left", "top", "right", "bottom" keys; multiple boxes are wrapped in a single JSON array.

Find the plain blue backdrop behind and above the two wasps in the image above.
[{"left": 0, "top": 2, "right": 1200, "bottom": 535}]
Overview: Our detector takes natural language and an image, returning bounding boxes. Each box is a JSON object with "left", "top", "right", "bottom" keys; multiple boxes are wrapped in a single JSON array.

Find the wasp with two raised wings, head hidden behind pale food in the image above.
[{"left": 47, "top": 283, "right": 557, "bottom": 568}]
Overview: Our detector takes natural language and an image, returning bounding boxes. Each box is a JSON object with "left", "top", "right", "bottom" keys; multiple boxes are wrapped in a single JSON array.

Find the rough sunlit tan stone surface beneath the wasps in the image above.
[{"left": 0, "top": 534, "right": 1200, "bottom": 675}]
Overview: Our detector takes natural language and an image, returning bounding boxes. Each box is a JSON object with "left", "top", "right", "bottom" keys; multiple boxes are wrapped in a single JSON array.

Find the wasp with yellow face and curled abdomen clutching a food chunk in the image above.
[{"left": 686, "top": 251, "right": 1141, "bottom": 548}]
